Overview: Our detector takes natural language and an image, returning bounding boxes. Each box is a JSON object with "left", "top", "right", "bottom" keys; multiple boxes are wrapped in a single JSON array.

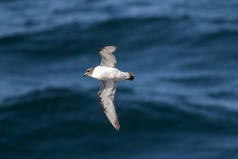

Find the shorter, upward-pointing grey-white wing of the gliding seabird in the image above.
[{"left": 99, "top": 46, "right": 117, "bottom": 67}]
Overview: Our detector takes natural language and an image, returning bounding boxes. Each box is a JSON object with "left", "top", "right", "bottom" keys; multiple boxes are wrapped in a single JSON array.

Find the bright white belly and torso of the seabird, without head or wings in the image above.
[{"left": 91, "top": 66, "right": 130, "bottom": 81}]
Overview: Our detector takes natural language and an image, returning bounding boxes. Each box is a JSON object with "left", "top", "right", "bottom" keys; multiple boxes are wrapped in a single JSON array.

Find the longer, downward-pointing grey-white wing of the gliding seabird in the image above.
[{"left": 98, "top": 80, "right": 120, "bottom": 130}]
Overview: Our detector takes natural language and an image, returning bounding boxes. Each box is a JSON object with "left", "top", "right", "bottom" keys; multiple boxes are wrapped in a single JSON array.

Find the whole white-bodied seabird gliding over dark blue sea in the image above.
[{"left": 83, "top": 46, "right": 135, "bottom": 130}]
